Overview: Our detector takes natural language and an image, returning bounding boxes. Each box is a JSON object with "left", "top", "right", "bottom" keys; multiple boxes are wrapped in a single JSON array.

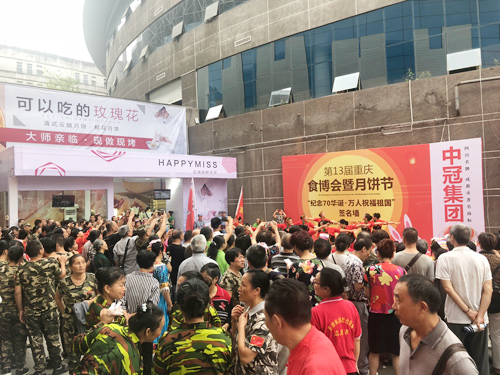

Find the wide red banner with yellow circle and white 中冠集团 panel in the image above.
[{"left": 282, "top": 138, "right": 485, "bottom": 239}]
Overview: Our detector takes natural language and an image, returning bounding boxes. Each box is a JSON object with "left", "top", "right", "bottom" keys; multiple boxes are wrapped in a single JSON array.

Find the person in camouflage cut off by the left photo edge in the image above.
[{"left": 0, "top": 244, "right": 28, "bottom": 373}]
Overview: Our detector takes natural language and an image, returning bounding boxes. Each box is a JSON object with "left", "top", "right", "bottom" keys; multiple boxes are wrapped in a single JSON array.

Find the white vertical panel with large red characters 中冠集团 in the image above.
[{"left": 429, "top": 138, "right": 485, "bottom": 237}]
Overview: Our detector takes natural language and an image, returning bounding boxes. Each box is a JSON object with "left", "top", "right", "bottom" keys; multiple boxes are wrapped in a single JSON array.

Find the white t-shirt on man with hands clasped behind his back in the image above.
[{"left": 436, "top": 246, "right": 492, "bottom": 324}]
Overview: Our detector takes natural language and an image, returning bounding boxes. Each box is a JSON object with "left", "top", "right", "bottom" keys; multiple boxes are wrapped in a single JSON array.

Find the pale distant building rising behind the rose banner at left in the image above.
[{"left": 0, "top": 46, "right": 107, "bottom": 95}]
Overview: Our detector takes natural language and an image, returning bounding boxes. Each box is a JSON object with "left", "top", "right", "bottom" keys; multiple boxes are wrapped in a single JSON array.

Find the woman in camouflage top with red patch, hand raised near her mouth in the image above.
[{"left": 231, "top": 270, "right": 279, "bottom": 375}]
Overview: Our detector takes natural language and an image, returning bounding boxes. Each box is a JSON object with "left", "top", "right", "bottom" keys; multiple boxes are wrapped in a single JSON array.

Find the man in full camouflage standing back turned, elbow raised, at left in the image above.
[{"left": 15, "top": 241, "right": 67, "bottom": 375}]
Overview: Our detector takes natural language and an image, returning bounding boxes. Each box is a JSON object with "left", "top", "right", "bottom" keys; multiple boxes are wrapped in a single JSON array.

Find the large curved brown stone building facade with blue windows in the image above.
[{"left": 84, "top": 0, "right": 500, "bottom": 231}]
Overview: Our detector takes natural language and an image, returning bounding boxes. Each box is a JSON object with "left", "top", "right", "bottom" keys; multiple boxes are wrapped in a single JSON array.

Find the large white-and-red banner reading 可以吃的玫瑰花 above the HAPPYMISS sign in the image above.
[{"left": 0, "top": 84, "right": 187, "bottom": 154}]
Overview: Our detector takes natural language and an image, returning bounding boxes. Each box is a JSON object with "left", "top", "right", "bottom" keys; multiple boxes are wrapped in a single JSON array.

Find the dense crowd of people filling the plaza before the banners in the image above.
[{"left": 0, "top": 210, "right": 500, "bottom": 375}]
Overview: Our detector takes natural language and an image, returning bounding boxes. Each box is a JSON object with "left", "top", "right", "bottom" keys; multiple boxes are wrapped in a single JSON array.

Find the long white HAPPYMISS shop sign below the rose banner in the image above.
[{"left": 12, "top": 146, "right": 236, "bottom": 179}]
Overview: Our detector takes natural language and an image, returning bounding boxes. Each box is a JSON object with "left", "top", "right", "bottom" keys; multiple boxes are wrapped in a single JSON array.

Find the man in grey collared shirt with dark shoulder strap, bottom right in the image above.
[{"left": 393, "top": 273, "right": 477, "bottom": 375}]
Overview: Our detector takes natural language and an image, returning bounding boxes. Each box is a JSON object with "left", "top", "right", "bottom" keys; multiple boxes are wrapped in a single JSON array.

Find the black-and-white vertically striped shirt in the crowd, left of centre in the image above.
[{"left": 125, "top": 271, "right": 160, "bottom": 313}]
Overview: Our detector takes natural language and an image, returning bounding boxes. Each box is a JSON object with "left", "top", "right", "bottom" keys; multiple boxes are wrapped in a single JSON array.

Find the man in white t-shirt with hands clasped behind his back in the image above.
[{"left": 436, "top": 224, "right": 493, "bottom": 375}]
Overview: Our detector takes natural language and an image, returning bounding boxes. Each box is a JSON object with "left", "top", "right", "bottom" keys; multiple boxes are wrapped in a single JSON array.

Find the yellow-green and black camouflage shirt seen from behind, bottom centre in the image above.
[{"left": 153, "top": 321, "right": 231, "bottom": 375}]
